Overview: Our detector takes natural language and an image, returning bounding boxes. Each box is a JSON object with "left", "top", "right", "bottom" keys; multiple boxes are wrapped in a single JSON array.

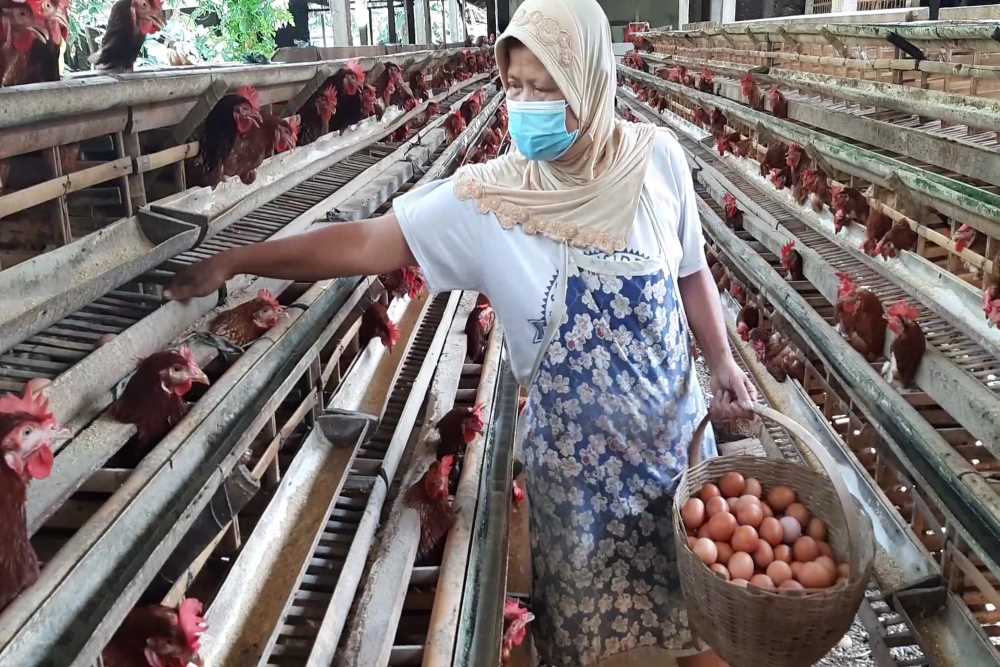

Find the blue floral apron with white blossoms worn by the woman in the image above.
[{"left": 523, "top": 190, "right": 717, "bottom": 667}]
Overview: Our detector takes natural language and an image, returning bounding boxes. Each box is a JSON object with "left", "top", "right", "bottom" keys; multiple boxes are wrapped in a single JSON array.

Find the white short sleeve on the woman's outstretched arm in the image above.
[{"left": 392, "top": 179, "right": 483, "bottom": 293}]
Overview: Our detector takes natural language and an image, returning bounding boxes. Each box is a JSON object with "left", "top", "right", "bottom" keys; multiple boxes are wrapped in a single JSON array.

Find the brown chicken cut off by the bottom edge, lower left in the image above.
[{"left": 101, "top": 598, "right": 208, "bottom": 667}]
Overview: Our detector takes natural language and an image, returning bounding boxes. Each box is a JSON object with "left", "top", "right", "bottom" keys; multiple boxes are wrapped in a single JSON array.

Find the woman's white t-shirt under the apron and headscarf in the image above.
[{"left": 393, "top": 132, "right": 706, "bottom": 384}]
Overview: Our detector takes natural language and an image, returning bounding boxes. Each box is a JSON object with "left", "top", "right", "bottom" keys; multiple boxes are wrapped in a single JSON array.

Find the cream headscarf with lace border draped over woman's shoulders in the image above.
[{"left": 455, "top": 0, "right": 656, "bottom": 253}]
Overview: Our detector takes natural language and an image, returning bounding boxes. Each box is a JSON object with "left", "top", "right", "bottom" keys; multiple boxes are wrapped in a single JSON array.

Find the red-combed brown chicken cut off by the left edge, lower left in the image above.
[{"left": 0, "top": 380, "right": 68, "bottom": 610}]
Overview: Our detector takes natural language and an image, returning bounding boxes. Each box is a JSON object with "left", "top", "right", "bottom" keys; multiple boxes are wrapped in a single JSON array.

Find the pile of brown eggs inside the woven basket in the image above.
[{"left": 681, "top": 472, "right": 848, "bottom": 591}]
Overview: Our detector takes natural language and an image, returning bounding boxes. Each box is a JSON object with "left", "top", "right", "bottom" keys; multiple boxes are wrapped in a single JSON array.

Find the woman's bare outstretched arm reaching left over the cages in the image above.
[{"left": 165, "top": 213, "right": 416, "bottom": 301}]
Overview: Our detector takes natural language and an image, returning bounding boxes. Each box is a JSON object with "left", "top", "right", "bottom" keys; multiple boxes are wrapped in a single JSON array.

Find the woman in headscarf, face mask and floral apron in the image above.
[{"left": 170, "top": 0, "right": 754, "bottom": 666}]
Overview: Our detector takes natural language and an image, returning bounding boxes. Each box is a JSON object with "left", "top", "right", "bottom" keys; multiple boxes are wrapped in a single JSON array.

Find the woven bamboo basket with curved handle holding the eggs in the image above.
[{"left": 673, "top": 406, "right": 875, "bottom": 667}]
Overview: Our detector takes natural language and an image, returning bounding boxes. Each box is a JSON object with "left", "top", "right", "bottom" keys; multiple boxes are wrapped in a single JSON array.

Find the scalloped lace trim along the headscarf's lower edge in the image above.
[{"left": 455, "top": 177, "right": 628, "bottom": 254}]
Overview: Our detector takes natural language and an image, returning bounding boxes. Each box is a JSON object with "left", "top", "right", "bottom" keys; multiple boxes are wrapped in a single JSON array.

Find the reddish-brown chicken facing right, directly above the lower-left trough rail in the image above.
[{"left": 111, "top": 346, "right": 209, "bottom": 454}]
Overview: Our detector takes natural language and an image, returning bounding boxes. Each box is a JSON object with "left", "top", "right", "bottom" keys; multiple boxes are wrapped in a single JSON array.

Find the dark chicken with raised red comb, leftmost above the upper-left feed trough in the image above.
[{"left": 184, "top": 89, "right": 263, "bottom": 188}]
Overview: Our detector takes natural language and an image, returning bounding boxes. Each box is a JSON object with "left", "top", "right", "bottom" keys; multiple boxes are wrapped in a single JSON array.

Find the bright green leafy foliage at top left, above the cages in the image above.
[{"left": 194, "top": 0, "right": 292, "bottom": 60}]
